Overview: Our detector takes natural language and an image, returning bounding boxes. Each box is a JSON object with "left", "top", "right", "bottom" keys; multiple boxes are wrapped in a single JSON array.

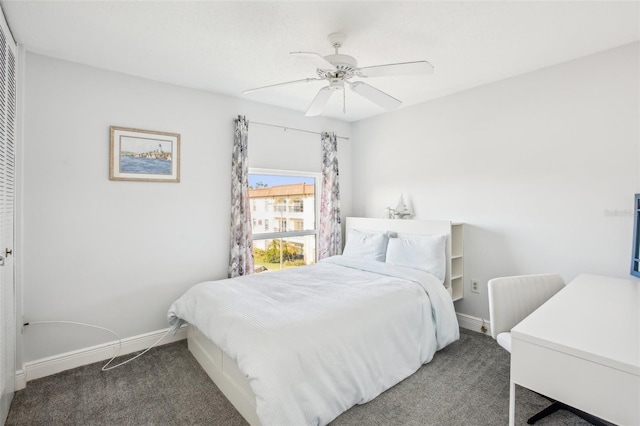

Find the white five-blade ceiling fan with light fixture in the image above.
[{"left": 242, "top": 33, "right": 433, "bottom": 116}]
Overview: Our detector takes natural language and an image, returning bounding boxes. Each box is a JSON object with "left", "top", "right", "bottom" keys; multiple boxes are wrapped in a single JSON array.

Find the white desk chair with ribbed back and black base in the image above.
[{"left": 488, "top": 274, "right": 605, "bottom": 426}]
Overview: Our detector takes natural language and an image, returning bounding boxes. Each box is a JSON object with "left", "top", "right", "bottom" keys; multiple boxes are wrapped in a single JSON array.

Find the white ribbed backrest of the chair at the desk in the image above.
[{"left": 488, "top": 274, "right": 565, "bottom": 339}]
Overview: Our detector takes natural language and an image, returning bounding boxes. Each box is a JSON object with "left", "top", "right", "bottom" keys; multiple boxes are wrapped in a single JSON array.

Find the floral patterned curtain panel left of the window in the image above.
[{"left": 229, "top": 116, "right": 253, "bottom": 278}]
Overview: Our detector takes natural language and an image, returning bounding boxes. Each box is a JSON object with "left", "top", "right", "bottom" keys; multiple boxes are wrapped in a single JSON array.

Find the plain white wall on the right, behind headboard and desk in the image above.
[{"left": 352, "top": 43, "right": 640, "bottom": 319}]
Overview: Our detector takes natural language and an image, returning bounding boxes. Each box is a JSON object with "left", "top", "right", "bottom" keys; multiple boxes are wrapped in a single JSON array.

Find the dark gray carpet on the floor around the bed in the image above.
[{"left": 6, "top": 329, "right": 600, "bottom": 426}]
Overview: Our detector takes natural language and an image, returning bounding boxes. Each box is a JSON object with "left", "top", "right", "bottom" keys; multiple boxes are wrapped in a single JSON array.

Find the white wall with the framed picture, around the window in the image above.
[{"left": 18, "top": 53, "right": 351, "bottom": 366}]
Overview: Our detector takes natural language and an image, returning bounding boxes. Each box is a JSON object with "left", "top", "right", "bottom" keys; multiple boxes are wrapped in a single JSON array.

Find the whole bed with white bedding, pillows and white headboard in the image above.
[{"left": 168, "top": 218, "right": 459, "bottom": 426}]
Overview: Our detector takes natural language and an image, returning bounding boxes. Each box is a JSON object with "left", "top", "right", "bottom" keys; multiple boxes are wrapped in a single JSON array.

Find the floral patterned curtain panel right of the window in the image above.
[{"left": 318, "top": 132, "right": 342, "bottom": 260}]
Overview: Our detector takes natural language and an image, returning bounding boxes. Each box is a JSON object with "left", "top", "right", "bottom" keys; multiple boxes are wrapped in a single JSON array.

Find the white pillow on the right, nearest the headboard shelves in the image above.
[{"left": 387, "top": 234, "right": 447, "bottom": 282}]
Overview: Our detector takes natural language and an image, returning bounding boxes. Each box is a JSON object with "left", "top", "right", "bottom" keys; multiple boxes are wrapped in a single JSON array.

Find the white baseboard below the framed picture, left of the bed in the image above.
[{"left": 16, "top": 327, "right": 187, "bottom": 390}]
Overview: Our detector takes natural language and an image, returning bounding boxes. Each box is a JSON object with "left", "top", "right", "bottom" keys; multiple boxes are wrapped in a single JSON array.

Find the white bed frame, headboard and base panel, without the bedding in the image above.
[{"left": 187, "top": 217, "right": 452, "bottom": 426}]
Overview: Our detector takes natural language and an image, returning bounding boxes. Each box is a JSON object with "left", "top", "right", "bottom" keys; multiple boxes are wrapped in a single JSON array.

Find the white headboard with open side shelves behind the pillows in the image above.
[{"left": 346, "top": 217, "right": 463, "bottom": 300}]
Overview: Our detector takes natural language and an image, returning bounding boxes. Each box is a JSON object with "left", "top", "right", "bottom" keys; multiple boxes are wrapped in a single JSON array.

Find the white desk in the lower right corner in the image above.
[{"left": 509, "top": 275, "right": 640, "bottom": 426}]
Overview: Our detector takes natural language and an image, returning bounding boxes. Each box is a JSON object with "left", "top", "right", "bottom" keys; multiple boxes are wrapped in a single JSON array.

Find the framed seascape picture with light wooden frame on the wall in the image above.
[{"left": 109, "top": 126, "right": 180, "bottom": 182}]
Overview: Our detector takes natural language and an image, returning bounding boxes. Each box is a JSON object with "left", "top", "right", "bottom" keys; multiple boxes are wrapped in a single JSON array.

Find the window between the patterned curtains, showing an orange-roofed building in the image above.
[{"left": 249, "top": 169, "right": 320, "bottom": 271}]
